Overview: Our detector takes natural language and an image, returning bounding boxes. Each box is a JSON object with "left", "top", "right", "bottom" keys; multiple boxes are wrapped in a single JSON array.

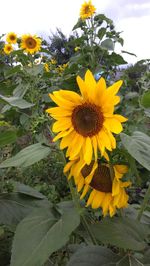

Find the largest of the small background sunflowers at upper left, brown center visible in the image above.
[{"left": 20, "top": 34, "right": 42, "bottom": 54}]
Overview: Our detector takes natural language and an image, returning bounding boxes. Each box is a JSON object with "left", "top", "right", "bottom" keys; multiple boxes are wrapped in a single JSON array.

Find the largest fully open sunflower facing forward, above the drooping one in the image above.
[{"left": 46, "top": 70, "right": 127, "bottom": 165}]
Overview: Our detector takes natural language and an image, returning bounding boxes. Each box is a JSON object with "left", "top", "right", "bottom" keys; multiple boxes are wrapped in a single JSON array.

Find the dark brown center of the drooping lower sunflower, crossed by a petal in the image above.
[{"left": 81, "top": 162, "right": 112, "bottom": 193}]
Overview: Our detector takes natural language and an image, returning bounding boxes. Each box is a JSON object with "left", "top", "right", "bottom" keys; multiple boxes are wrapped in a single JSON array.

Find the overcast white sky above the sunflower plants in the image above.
[{"left": 0, "top": 0, "right": 150, "bottom": 63}]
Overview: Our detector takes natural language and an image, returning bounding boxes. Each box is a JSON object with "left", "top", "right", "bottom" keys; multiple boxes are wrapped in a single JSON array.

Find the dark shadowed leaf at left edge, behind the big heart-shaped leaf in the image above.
[{"left": 0, "top": 192, "right": 50, "bottom": 225}]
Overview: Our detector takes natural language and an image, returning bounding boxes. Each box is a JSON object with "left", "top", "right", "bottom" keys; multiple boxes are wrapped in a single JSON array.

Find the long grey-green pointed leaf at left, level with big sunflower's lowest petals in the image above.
[{"left": 0, "top": 143, "right": 50, "bottom": 168}]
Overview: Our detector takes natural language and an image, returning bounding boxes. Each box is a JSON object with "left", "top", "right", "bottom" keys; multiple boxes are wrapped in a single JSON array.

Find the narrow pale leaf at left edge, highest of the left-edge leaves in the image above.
[{"left": 0, "top": 95, "right": 34, "bottom": 109}]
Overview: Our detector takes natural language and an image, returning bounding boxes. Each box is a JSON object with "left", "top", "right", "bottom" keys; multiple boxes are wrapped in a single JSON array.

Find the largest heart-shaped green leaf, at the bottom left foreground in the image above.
[{"left": 11, "top": 202, "right": 80, "bottom": 266}]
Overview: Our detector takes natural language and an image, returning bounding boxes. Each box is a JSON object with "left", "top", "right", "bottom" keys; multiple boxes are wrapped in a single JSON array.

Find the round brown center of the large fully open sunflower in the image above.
[{"left": 72, "top": 103, "right": 104, "bottom": 137}]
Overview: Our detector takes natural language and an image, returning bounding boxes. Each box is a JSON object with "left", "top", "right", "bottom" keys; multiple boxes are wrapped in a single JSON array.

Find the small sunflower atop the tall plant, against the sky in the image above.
[{"left": 80, "top": 1, "right": 96, "bottom": 19}]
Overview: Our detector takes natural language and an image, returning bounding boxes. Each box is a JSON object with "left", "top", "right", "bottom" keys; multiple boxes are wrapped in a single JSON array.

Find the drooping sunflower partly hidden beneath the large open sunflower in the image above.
[{"left": 64, "top": 161, "right": 131, "bottom": 217}]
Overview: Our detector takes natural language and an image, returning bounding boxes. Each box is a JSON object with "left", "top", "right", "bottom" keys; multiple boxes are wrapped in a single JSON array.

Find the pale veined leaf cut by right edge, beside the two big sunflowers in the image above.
[{"left": 120, "top": 131, "right": 150, "bottom": 171}]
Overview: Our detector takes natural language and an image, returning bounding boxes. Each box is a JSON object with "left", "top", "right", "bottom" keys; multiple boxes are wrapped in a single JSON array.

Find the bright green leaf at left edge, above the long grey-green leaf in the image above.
[{"left": 0, "top": 130, "right": 17, "bottom": 147}]
